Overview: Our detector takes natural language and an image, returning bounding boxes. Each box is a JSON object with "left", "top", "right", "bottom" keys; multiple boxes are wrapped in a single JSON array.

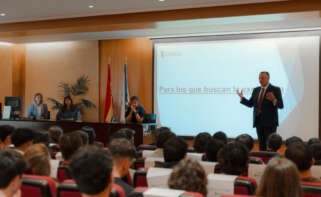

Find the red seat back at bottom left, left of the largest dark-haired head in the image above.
[{"left": 21, "top": 175, "right": 56, "bottom": 197}]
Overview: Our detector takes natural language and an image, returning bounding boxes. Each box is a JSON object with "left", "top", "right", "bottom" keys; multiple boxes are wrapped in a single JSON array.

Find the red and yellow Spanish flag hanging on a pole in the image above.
[{"left": 104, "top": 64, "right": 113, "bottom": 123}]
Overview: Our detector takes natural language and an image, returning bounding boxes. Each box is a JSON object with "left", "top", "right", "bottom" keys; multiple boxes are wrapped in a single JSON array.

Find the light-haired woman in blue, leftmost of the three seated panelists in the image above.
[{"left": 28, "top": 93, "right": 49, "bottom": 120}]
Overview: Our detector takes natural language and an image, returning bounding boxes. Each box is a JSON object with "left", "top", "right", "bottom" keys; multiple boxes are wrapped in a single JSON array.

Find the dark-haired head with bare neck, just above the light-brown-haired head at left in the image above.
[{"left": 11, "top": 128, "right": 33, "bottom": 155}]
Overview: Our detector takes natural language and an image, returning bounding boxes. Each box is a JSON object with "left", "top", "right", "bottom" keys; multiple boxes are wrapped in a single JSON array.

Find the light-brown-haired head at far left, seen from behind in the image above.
[{"left": 24, "top": 144, "right": 50, "bottom": 176}]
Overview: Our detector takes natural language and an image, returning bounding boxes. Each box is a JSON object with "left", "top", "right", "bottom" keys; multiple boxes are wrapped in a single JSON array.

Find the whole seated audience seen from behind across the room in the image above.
[{"left": 0, "top": 126, "right": 321, "bottom": 197}]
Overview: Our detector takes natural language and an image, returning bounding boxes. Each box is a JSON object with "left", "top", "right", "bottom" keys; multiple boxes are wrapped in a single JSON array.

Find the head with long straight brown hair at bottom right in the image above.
[{"left": 256, "top": 157, "right": 302, "bottom": 197}]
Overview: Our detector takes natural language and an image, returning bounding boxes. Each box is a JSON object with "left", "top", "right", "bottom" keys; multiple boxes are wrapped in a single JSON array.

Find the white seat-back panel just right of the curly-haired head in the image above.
[{"left": 207, "top": 174, "right": 237, "bottom": 197}]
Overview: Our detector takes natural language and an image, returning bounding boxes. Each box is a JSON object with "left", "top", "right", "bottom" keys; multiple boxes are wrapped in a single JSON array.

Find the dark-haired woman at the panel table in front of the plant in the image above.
[{"left": 56, "top": 96, "right": 80, "bottom": 121}]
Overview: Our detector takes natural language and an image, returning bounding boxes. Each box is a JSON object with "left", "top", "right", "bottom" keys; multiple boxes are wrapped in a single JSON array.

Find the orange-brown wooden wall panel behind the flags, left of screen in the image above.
[{"left": 99, "top": 38, "right": 153, "bottom": 121}]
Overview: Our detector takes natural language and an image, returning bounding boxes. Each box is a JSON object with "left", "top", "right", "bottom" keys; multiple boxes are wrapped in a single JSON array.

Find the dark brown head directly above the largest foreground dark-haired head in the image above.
[{"left": 59, "top": 132, "right": 83, "bottom": 161}]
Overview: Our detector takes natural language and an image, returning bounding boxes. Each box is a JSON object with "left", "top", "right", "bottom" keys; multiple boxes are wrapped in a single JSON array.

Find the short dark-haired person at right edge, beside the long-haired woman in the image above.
[{"left": 285, "top": 143, "right": 321, "bottom": 182}]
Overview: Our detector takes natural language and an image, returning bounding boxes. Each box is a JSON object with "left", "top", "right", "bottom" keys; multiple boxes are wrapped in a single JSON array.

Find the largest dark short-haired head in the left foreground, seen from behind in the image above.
[{"left": 70, "top": 146, "right": 113, "bottom": 197}]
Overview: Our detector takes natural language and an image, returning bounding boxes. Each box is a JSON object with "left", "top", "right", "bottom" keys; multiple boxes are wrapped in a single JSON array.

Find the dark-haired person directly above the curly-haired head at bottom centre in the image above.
[{"left": 156, "top": 136, "right": 188, "bottom": 168}]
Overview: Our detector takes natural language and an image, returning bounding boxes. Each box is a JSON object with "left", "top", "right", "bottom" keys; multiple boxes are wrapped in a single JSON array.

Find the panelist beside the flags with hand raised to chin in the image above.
[{"left": 125, "top": 96, "right": 146, "bottom": 123}]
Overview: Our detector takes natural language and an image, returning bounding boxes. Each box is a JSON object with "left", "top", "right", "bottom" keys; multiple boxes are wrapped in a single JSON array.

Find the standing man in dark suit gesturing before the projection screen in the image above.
[{"left": 237, "top": 72, "right": 283, "bottom": 151}]
